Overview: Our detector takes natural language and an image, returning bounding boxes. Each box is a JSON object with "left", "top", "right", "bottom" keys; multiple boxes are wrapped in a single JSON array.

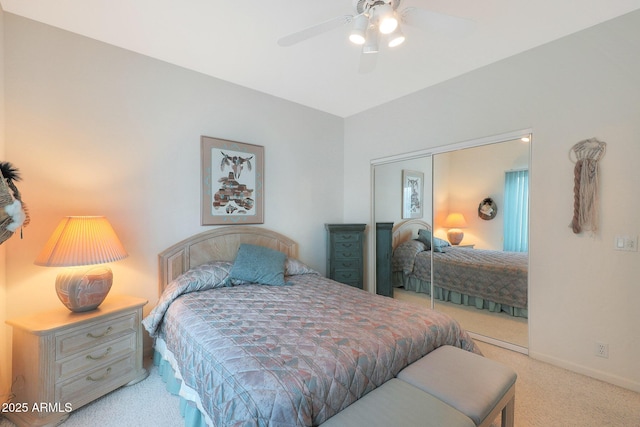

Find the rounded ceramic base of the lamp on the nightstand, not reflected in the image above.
[{"left": 56, "top": 266, "right": 113, "bottom": 312}]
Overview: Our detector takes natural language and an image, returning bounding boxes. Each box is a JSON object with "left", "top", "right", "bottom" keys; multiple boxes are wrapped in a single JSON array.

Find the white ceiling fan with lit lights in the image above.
[{"left": 278, "top": 0, "right": 474, "bottom": 72}]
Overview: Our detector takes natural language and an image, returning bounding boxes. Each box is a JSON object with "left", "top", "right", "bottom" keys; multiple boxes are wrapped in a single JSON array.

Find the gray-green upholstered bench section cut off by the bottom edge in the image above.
[{"left": 322, "top": 378, "right": 474, "bottom": 427}]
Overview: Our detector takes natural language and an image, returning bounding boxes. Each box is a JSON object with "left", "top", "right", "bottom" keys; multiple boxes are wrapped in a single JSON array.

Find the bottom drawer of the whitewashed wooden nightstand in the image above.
[{"left": 55, "top": 353, "right": 136, "bottom": 409}]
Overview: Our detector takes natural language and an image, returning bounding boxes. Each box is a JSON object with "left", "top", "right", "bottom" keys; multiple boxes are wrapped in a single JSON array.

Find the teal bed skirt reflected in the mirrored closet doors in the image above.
[{"left": 393, "top": 271, "right": 529, "bottom": 318}]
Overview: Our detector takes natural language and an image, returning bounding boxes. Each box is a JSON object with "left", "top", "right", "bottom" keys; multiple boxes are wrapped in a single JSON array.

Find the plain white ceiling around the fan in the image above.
[{"left": 0, "top": 0, "right": 640, "bottom": 117}]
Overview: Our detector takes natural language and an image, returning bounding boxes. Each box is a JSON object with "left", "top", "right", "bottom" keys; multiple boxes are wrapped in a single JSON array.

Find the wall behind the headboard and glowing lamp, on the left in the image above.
[{"left": 0, "top": 14, "right": 343, "bottom": 365}]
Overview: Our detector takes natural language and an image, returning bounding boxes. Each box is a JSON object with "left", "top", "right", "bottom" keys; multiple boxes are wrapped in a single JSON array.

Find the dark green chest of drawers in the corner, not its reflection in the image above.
[{"left": 325, "top": 224, "right": 366, "bottom": 289}]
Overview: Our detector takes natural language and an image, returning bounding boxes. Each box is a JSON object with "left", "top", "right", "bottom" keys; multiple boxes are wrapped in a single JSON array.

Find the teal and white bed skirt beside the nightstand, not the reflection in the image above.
[{"left": 153, "top": 338, "right": 213, "bottom": 427}]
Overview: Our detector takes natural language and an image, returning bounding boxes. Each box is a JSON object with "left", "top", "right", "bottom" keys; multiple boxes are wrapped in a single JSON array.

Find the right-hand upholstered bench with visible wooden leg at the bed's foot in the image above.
[{"left": 397, "top": 346, "right": 517, "bottom": 427}]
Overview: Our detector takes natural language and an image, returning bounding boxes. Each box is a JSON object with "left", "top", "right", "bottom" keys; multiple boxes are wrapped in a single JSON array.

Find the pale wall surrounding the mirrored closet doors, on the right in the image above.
[{"left": 344, "top": 12, "right": 640, "bottom": 391}]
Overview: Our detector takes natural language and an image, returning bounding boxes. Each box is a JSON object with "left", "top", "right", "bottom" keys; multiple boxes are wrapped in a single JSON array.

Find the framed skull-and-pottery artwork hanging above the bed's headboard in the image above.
[{"left": 200, "top": 136, "right": 264, "bottom": 225}]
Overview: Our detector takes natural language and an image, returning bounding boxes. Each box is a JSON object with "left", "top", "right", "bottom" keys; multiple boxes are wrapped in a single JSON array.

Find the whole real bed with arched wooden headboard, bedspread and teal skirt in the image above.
[{"left": 143, "top": 226, "right": 480, "bottom": 427}]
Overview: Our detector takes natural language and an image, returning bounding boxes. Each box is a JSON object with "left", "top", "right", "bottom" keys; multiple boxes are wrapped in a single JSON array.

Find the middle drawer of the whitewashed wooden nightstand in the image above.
[{"left": 56, "top": 334, "right": 137, "bottom": 380}]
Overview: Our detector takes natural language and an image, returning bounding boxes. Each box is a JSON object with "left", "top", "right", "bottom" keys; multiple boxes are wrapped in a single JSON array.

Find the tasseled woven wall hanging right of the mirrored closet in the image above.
[{"left": 569, "top": 138, "right": 607, "bottom": 234}]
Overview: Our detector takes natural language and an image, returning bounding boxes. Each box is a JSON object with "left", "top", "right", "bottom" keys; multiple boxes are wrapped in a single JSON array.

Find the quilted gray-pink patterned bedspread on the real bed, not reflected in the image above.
[{"left": 143, "top": 274, "right": 479, "bottom": 427}]
